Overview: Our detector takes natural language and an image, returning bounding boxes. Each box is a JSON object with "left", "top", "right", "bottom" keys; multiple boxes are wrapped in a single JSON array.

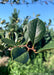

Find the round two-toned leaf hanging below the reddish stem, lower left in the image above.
[{"left": 12, "top": 47, "right": 29, "bottom": 63}]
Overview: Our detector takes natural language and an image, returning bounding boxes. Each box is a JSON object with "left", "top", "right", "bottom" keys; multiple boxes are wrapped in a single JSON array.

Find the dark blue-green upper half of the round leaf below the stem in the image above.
[{"left": 12, "top": 47, "right": 26, "bottom": 59}]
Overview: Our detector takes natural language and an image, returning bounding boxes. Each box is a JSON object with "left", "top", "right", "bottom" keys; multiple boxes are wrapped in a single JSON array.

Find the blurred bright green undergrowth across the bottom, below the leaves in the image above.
[{"left": 0, "top": 51, "right": 54, "bottom": 75}]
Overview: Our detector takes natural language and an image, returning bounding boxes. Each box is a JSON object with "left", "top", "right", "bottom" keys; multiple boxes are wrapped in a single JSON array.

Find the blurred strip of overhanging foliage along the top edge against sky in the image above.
[{"left": 0, "top": 0, "right": 54, "bottom": 5}]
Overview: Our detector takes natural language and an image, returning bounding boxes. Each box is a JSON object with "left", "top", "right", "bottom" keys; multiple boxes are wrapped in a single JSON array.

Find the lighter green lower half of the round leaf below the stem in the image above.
[{"left": 14, "top": 52, "right": 29, "bottom": 64}]
